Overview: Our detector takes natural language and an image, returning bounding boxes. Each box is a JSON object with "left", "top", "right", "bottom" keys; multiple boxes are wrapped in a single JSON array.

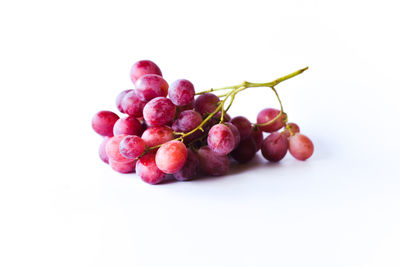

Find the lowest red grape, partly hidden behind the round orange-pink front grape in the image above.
[{"left": 136, "top": 152, "right": 165, "bottom": 184}]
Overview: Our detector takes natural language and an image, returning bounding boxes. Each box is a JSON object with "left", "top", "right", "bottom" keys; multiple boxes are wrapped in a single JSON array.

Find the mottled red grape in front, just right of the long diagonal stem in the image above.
[{"left": 207, "top": 124, "right": 235, "bottom": 155}]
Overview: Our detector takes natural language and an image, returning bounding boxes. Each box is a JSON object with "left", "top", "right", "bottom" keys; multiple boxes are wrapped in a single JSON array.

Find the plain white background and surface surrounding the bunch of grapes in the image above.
[{"left": 0, "top": 0, "right": 400, "bottom": 267}]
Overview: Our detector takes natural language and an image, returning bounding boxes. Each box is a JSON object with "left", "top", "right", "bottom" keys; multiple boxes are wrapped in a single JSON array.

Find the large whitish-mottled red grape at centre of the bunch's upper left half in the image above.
[{"left": 143, "top": 97, "right": 176, "bottom": 126}]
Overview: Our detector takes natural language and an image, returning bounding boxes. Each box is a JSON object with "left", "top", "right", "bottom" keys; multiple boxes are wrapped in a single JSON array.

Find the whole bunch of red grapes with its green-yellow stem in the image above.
[{"left": 92, "top": 60, "right": 314, "bottom": 184}]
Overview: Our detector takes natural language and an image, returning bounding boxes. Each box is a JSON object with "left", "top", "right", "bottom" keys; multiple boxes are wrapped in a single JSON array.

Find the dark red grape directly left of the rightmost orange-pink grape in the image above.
[{"left": 261, "top": 132, "right": 289, "bottom": 162}]
